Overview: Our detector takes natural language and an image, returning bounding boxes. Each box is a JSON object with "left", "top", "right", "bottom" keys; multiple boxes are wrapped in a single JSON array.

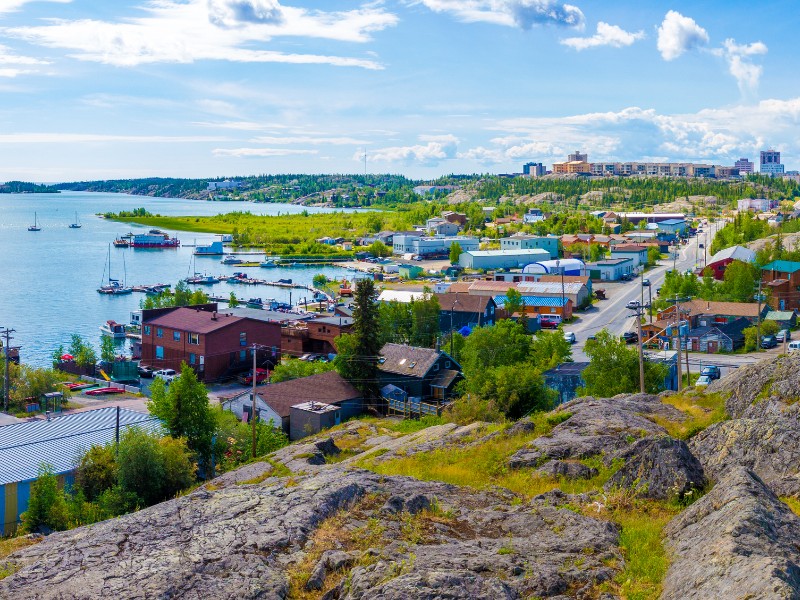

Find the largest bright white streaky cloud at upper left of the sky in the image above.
[{"left": 4, "top": 0, "right": 397, "bottom": 69}]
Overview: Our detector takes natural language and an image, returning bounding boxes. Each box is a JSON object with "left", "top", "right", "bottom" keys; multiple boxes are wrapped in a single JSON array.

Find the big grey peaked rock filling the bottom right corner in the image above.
[{"left": 661, "top": 468, "right": 800, "bottom": 600}]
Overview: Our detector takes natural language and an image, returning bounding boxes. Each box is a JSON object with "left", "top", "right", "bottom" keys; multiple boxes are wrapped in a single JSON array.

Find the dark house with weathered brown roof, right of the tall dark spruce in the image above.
[{"left": 378, "top": 344, "right": 463, "bottom": 415}]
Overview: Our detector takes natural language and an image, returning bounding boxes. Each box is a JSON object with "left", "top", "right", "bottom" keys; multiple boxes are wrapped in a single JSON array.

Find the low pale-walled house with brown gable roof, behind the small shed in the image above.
[{"left": 220, "top": 371, "right": 364, "bottom": 440}]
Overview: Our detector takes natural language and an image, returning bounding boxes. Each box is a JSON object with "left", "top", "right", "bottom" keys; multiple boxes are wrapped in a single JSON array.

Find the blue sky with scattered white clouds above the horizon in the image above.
[{"left": 0, "top": 0, "right": 800, "bottom": 182}]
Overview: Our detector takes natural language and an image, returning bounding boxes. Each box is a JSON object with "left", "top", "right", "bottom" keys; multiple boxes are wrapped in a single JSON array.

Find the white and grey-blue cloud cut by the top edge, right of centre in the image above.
[{"left": 410, "top": 0, "right": 585, "bottom": 29}]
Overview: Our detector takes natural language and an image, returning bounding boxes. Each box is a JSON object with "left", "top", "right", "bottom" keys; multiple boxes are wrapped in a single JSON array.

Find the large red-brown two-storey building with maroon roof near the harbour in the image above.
[{"left": 142, "top": 304, "right": 281, "bottom": 381}]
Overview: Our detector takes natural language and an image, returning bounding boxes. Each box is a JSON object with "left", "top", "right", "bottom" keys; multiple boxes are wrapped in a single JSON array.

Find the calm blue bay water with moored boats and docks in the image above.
[{"left": 0, "top": 192, "right": 362, "bottom": 366}]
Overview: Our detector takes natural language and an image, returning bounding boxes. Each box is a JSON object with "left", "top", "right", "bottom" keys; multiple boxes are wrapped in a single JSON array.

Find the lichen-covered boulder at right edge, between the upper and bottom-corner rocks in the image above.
[{"left": 689, "top": 415, "right": 800, "bottom": 492}]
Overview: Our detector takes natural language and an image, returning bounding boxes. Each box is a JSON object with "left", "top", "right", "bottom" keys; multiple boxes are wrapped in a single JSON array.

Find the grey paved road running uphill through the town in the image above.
[{"left": 567, "top": 221, "right": 723, "bottom": 362}]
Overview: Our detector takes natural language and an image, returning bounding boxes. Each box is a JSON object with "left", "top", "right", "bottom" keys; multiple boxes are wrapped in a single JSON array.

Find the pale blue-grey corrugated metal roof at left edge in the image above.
[{"left": 0, "top": 406, "right": 161, "bottom": 485}]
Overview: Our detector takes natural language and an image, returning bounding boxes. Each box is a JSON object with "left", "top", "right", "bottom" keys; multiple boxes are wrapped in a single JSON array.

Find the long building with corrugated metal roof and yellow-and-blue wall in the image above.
[{"left": 0, "top": 406, "right": 161, "bottom": 536}]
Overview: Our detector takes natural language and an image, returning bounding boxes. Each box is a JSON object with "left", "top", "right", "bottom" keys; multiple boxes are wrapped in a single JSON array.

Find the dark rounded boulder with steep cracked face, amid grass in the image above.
[{"left": 605, "top": 436, "right": 706, "bottom": 500}]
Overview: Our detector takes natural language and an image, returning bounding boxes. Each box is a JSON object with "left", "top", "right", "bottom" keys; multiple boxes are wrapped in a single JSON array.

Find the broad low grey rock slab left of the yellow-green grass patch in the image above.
[{"left": 509, "top": 394, "right": 686, "bottom": 468}]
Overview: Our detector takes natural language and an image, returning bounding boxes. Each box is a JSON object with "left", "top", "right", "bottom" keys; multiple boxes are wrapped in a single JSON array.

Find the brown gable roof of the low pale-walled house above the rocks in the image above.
[{"left": 225, "top": 371, "right": 362, "bottom": 418}]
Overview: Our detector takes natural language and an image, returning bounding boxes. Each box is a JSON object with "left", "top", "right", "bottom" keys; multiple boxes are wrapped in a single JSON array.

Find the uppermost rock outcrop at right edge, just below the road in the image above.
[{"left": 706, "top": 353, "right": 800, "bottom": 419}]
